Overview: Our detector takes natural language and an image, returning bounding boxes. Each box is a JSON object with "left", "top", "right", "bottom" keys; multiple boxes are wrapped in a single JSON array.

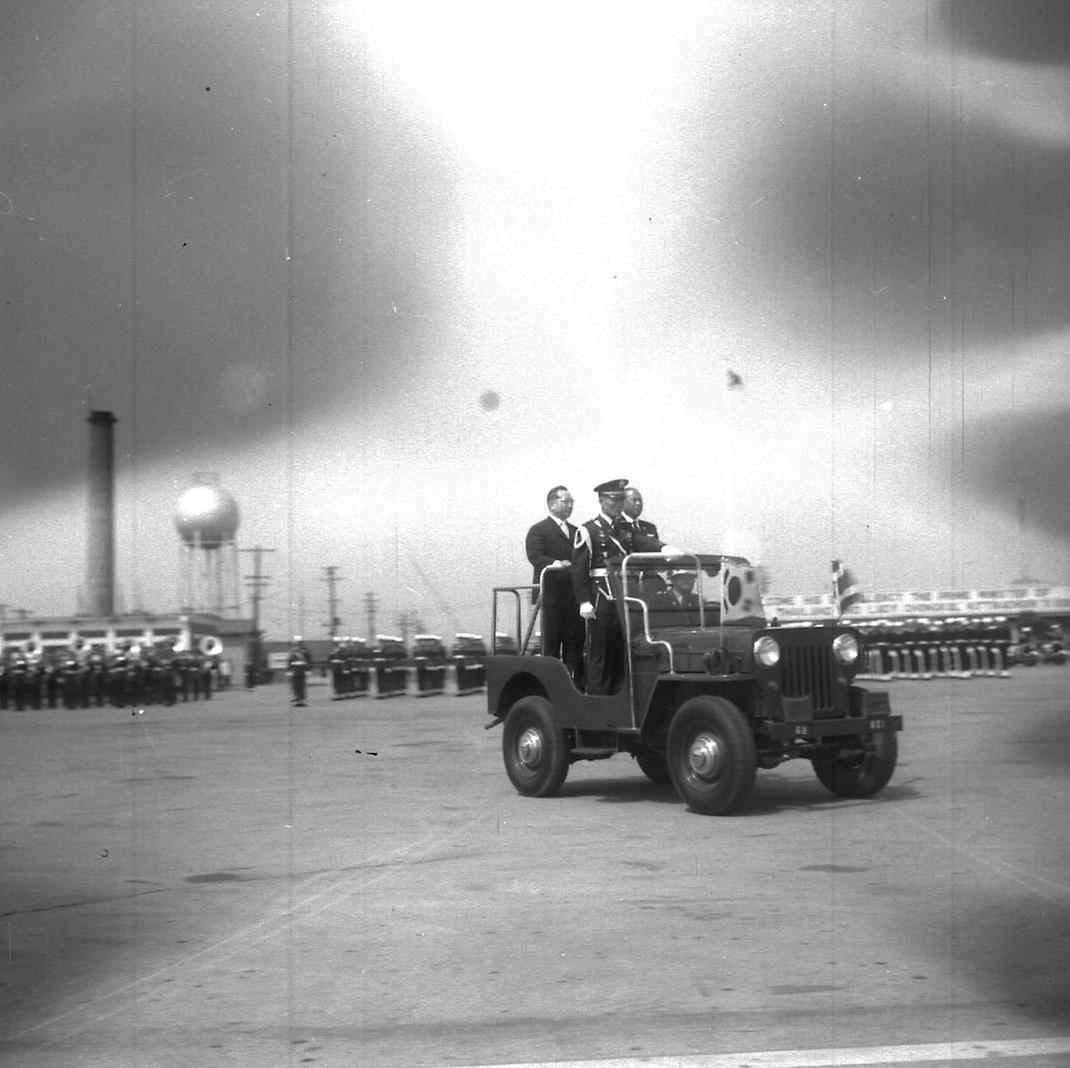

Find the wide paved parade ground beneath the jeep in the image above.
[{"left": 0, "top": 667, "right": 1070, "bottom": 1068}]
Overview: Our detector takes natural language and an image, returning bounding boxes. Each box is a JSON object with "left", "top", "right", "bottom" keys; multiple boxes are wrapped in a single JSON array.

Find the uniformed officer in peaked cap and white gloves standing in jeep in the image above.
[{"left": 572, "top": 478, "right": 676, "bottom": 693}]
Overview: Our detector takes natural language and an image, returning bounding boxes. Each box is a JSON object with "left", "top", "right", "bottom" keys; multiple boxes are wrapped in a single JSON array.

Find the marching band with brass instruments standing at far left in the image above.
[{"left": 0, "top": 641, "right": 220, "bottom": 711}]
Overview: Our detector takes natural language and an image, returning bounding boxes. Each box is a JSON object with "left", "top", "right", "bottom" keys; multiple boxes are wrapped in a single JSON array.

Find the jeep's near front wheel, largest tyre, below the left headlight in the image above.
[{"left": 668, "top": 696, "right": 758, "bottom": 815}]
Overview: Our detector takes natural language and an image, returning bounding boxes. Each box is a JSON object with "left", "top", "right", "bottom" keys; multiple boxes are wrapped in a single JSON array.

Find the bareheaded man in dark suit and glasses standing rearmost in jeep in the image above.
[{"left": 524, "top": 486, "right": 583, "bottom": 678}]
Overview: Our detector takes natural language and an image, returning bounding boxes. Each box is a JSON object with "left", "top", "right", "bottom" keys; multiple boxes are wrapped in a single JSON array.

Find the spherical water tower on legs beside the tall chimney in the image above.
[{"left": 174, "top": 473, "right": 241, "bottom": 615}]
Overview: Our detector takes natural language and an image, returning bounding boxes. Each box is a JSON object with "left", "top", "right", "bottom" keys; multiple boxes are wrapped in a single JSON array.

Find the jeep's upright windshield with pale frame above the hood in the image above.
[{"left": 621, "top": 552, "right": 765, "bottom": 631}]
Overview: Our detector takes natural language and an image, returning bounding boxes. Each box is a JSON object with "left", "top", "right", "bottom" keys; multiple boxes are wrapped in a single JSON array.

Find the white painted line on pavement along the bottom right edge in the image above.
[{"left": 449, "top": 1037, "right": 1070, "bottom": 1068}]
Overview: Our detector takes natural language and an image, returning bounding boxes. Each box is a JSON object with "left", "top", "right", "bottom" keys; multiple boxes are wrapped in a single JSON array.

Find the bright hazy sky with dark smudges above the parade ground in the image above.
[{"left": 0, "top": 0, "right": 1070, "bottom": 637}]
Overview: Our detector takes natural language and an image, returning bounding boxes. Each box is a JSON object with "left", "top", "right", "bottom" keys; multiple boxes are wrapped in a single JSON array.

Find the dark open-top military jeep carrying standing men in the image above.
[{"left": 487, "top": 553, "right": 902, "bottom": 815}]
